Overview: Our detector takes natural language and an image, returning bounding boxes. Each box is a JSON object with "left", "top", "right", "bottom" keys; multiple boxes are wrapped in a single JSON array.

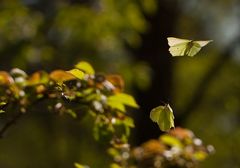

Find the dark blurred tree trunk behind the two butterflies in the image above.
[{"left": 135, "top": 0, "right": 178, "bottom": 143}]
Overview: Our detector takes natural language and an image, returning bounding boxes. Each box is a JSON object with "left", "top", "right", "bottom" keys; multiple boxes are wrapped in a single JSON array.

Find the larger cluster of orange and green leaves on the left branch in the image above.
[{"left": 0, "top": 61, "right": 138, "bottom": 141}]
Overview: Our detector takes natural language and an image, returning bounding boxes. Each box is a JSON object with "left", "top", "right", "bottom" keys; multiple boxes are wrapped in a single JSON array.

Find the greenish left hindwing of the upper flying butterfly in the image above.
[{"left": 169, "top": 42, "right": 189, "bottom": 57}]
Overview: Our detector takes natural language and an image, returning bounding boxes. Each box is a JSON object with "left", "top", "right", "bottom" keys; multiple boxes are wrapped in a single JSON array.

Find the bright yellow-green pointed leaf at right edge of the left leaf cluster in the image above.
[{"left": 107, "top": 93, "right": 139, "bottom": 112}]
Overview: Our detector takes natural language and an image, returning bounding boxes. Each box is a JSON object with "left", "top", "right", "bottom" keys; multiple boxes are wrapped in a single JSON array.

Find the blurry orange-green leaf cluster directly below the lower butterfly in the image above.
[{"left": 132, "top": 127, "right": 214, "bottom": 168}]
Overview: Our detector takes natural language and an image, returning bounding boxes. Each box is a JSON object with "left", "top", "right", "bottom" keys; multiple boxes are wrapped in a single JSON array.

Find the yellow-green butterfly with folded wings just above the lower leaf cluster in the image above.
[{"left": 150, "top": 104, "right": 174, "bottom": 131}]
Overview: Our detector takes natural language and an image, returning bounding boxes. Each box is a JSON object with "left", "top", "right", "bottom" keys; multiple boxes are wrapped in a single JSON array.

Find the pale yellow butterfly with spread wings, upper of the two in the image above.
[{"left": 167, "top": 37, "right": 212, "bottom": 57}]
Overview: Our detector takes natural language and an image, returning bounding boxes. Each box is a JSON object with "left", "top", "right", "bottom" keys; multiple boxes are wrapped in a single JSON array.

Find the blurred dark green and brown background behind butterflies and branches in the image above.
[{"left": 0, "top": 0, "right": 240, "bottom": 168}]
